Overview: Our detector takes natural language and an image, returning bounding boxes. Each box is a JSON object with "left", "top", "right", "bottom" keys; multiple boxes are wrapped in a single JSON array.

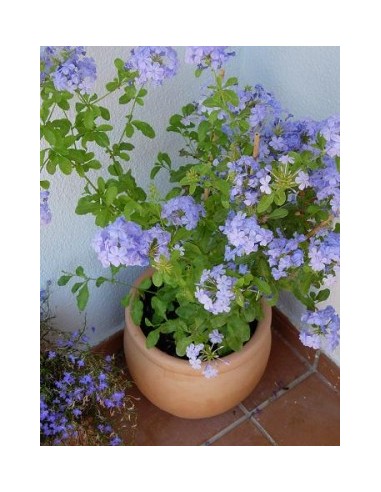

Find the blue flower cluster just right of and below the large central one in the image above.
[{"left": 264, "top": 230, "right": 306, "bottom": 280}]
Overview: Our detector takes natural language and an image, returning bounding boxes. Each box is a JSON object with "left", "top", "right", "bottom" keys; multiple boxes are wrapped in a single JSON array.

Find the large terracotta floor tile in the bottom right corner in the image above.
[{"left": 256, "top": 374, "right": 340, "bottom": 446}]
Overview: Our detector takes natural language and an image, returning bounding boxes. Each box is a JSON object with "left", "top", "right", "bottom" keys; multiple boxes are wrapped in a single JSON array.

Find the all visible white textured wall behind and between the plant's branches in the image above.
[{"left": 40, "top": 47, "right": 339, "bottom": 362}]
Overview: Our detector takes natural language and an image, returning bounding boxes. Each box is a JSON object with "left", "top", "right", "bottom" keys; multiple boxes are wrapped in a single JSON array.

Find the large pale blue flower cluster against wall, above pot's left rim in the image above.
[{"left": 92, "top": 217, "right": 171, "bottom": 267}]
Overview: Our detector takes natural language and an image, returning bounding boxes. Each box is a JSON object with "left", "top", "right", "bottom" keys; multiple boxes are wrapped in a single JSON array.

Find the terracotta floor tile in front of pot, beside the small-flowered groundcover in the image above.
[{"left": 123, "top": 387, "right": 243, "bottom": 446}]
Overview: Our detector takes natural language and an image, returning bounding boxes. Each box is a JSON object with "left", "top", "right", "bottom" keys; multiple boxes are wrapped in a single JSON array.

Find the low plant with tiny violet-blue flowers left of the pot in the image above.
[{"left": 40, "top": 289, "right": 136, "bottom": 446}]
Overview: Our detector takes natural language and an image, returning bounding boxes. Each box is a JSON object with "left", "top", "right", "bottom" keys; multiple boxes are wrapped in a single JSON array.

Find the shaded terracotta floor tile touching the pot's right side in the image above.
[{"left": 242, "top": 331, "right": 308, "bottom": 410}]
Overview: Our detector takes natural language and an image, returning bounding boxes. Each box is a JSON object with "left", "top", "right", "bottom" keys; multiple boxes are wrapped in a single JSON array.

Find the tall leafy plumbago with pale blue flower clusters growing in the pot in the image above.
[{"left": 41, "top": 46, "right": 340, "bottom": 377}]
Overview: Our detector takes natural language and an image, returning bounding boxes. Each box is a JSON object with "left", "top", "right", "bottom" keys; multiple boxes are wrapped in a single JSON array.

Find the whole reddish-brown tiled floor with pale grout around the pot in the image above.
[{"left": 112, "top": 313, "right": 340, "bottom": 446}]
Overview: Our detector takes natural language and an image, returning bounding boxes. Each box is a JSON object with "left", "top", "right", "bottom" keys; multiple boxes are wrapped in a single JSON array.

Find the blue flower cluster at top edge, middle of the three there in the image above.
[{"left": 125, "top": 46, "right": 179, "bottom": 85}]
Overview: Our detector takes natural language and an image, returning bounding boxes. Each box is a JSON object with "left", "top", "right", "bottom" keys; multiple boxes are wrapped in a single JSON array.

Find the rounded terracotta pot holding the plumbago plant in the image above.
[{"left": 124, "top": 269, "right": 271, "bottom": 419}]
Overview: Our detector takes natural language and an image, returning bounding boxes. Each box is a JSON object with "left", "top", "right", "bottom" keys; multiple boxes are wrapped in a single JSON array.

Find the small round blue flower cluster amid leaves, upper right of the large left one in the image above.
[{"left": 161, "top": 196, "right": 205, "bottom": 231}]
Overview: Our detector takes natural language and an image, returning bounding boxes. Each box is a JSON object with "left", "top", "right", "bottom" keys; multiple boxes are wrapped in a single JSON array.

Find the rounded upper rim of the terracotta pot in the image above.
[{"left": 125, "top": 267, "right": 272, "bottom": 377}]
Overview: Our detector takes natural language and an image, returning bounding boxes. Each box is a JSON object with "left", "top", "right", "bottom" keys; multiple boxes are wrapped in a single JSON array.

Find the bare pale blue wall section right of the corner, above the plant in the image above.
[{"left": 240, "top": 46, "right": 340, "bottom": 119}]
